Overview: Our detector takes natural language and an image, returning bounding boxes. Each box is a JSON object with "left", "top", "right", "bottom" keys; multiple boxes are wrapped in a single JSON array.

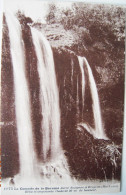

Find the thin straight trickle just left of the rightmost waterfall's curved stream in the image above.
[{"left": 78, "top": 56, "right": 85, "bottom": 116}]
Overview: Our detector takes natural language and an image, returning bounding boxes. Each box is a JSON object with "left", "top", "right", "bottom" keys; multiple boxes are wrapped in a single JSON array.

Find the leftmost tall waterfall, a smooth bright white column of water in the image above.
[{"left": 6, "top": 14, "right": 35, "bottom": 177}]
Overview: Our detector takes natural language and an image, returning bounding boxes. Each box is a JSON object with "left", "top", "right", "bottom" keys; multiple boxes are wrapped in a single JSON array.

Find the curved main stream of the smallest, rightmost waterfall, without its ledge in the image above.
[{"left": 83, "top": 58, "right": 106, "bottom": 139}]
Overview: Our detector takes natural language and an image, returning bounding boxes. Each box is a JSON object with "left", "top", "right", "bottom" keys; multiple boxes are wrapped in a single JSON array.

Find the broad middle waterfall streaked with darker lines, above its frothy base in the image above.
[{"left": 31, "top": 28, "right": 61, "bottom": 161}]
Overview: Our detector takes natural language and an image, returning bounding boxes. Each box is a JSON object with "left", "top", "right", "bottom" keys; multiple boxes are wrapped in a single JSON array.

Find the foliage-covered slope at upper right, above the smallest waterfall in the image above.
[{"left": 47, "top": 3, "right": 125, "bottom": 83}]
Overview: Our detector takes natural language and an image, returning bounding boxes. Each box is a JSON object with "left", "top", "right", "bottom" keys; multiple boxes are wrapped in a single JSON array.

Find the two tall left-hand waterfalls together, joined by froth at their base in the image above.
[{"left": 6, "top": 14, "right": 70, "bottom": 182}]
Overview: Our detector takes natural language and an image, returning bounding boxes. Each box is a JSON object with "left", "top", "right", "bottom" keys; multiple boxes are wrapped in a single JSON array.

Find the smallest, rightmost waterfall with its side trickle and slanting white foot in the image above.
[{"left": 78, "top": 56, "right": 107, "bottom": 139}]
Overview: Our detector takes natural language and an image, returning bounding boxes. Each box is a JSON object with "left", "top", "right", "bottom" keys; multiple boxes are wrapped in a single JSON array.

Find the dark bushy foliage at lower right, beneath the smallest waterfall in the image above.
[{"left": 66, "top": 129, "right": 121, "bottom": 180}]
